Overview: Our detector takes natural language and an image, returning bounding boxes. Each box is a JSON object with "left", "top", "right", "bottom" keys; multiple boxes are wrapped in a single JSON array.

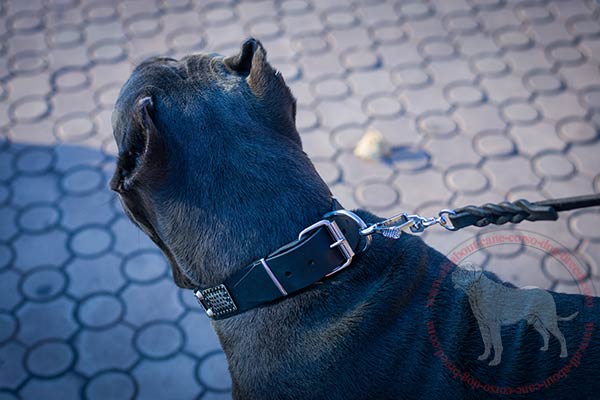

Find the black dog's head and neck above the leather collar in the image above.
[{"left": 110, "top": 39, "right": 329, "bottom": 287}]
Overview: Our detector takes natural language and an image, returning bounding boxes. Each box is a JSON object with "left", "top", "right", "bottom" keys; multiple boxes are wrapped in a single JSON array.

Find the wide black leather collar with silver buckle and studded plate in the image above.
[{"left": 194, "top": 200, "right": 370, "bottom": 319}]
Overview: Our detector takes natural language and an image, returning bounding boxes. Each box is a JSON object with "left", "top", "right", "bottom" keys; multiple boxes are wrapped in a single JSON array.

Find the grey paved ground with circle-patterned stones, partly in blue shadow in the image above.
[{"left": 0, "top": 0, "right": 600, "bottom": 400}]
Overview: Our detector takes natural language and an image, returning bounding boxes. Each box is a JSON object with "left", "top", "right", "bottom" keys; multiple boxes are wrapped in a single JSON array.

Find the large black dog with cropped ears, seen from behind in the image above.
[{"left": 111, "top": 39, "right": 600, "bottom": 399}]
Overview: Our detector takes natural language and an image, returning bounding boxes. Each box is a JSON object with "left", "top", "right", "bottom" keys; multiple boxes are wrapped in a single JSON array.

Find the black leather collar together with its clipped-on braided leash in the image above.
[{"left": 194, "top": 194, "right": 600, "bottom": 319}]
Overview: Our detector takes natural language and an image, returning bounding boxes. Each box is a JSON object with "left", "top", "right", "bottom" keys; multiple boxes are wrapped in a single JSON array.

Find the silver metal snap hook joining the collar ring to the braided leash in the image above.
[{"left": 360, "top": 209, "right": 456, "bottom": 239}]
